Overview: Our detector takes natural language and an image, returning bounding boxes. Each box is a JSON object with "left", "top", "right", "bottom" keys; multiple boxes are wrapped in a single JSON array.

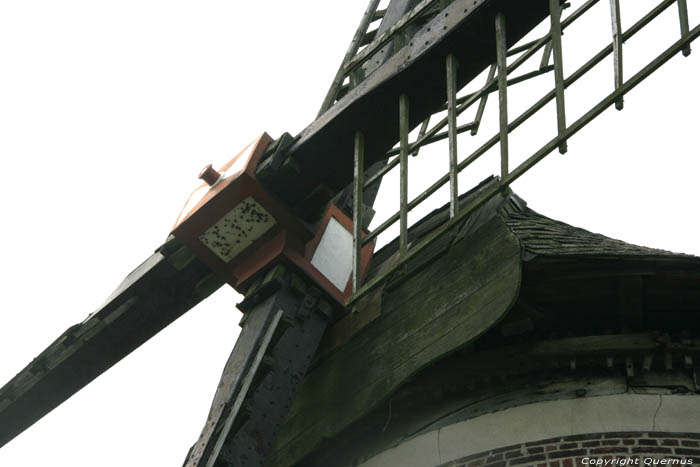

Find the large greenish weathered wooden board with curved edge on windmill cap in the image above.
[{"left": 271, "top": 218, "right": 520, "bottom": 465}]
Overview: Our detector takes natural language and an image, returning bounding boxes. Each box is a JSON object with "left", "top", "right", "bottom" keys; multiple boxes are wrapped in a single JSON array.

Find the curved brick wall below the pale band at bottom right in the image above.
[{"left": 440, "top": 432, "right": 700, "bottom": 467}]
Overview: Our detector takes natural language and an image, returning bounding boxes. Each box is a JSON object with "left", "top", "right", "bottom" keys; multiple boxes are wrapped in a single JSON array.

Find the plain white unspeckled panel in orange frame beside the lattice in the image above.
[{"left": 311, "top": 217, "right": 352, "bottom": 292}]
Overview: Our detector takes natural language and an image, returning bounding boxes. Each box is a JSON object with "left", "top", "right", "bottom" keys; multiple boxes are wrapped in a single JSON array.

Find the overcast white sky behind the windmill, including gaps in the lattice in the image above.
[{"left": 0, "top": 0, "right": 700, "bottom": 467}]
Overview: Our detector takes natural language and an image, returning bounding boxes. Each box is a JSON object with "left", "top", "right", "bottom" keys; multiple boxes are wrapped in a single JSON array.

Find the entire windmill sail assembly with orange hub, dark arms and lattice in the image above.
[{"left": 0, "top": 0, "right": 700, "bottom": 467}]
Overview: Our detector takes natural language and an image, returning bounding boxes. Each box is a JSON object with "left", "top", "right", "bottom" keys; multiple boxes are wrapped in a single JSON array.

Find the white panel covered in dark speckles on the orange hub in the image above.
[{"left": 199, "top": 196, "right": 276, "bottom": 262}]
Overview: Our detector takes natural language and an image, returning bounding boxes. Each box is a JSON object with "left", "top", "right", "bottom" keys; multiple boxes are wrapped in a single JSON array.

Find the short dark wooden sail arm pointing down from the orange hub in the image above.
[{"left": 206, "top": 287, "right": 328, "bottom": 467}]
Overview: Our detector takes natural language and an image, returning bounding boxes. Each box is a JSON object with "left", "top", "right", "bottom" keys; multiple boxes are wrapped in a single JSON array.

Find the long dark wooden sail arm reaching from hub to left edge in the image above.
[{"left": 0, "top": 246, "right": 222, "bottom": 446}]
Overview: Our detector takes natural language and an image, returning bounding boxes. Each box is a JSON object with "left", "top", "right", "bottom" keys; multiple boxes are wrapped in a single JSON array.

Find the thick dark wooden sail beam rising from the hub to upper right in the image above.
[{"left": 268, "top": 0, "right": 547, "bottom": 212}]
